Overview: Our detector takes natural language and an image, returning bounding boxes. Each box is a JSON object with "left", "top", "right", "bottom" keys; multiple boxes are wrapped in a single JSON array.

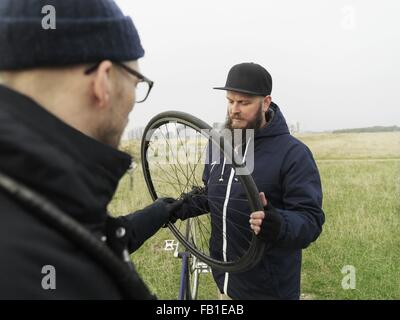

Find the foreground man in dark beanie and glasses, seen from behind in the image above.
[{"left": 0, "top": 0, "right": 180, "bottom": 299}]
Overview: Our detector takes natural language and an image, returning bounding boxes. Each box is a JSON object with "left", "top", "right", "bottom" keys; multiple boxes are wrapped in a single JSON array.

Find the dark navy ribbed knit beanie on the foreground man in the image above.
[{"left": 0, "top": 0, "right": 144, "bottom": 70}]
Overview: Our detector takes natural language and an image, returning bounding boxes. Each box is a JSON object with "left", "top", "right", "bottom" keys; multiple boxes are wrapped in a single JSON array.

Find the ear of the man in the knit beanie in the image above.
[{"left": 93, "top": 60, "right": 112, "bottom": 109}]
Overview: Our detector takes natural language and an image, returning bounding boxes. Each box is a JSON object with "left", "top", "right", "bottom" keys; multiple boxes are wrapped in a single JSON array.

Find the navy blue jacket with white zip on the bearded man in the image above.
[{"left": 180, "top": 103, "right": 324, "bottom": 299}]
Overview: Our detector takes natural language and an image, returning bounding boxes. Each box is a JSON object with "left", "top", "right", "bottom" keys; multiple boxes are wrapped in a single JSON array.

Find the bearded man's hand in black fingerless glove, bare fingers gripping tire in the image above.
[{"left": 249, "top": 192, "right": 284, "bottom": 243}]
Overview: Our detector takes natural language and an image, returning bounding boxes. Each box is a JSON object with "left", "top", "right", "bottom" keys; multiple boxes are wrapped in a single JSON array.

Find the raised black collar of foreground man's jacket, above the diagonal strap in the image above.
[{"left": 0, "top": 86, "right": 132, "bottom": 223}]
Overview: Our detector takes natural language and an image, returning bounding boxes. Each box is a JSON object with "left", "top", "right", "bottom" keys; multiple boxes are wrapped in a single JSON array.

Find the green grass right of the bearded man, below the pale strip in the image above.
[{"left": 302, "top": 161, "right": 400, "bottom": 299}]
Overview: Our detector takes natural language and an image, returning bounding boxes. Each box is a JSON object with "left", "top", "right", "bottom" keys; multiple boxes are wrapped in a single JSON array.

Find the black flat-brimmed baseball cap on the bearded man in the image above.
[{"left": 214, "top": 62, "right": 272, "bottom": 97}]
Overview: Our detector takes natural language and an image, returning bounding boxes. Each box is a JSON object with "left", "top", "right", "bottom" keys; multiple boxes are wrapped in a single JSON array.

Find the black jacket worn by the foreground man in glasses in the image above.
[{"left": 0, "top": 86, "right": 168, "bottom": 299}]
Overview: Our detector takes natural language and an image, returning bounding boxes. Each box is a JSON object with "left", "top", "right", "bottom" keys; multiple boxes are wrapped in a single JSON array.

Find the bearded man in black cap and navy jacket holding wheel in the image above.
[{"left": 176, "top": 63, "right": 324, "bottom": 299}]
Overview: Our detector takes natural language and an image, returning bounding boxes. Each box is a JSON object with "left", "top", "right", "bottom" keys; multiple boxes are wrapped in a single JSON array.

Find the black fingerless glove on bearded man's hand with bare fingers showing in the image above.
[{"left": 258, "top": 201, "right": 284, "bottom": 243}]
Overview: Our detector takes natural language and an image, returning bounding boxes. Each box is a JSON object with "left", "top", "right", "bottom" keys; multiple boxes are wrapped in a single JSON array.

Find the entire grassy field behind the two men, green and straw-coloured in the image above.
[{"left": 110, "top": 132, "right": 400, "bottom": 299}]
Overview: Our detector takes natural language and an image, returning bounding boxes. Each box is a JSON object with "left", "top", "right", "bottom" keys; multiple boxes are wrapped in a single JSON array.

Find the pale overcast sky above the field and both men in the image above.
[{"left": 117, "top": 0, "right": 400, "bottom": 131}]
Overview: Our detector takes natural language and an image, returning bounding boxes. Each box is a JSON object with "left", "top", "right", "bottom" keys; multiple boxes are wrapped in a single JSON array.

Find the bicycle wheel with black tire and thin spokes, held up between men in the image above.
[{"left": 141, "top": 111, "right": 264, "bottom": 272}]
